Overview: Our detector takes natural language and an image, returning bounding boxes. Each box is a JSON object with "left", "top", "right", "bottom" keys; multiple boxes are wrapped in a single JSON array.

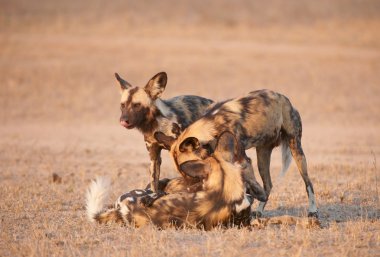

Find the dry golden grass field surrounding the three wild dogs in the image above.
[{"left": 0, "top": 0, "right": 380, "bottom": 257}]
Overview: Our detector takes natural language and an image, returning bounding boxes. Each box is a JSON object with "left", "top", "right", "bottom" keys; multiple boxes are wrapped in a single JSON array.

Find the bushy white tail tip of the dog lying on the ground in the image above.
[{"left": 86, "top": 177, "right": 111, "bottom": 222}]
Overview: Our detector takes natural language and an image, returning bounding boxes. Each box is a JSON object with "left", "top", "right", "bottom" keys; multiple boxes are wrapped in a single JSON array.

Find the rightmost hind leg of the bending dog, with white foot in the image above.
[{"left": 289, "top": 137, "right": 318, "bottom": 217}]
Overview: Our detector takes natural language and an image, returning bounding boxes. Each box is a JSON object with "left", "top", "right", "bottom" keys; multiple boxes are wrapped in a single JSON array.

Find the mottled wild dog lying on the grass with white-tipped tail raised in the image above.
[{"left": 86, "top": 132, "right": 252, "bottom": 230}]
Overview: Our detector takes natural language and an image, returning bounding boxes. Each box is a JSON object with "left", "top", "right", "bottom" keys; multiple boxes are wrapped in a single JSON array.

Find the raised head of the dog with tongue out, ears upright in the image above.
[{"left": 115, "top": 72, "right": 167, "bottom": 130}]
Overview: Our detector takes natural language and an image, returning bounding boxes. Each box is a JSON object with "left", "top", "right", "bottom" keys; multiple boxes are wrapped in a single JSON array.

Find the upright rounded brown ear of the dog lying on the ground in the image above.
[{"left": 215, "top": 131, "right": 244, "bottom": 163}]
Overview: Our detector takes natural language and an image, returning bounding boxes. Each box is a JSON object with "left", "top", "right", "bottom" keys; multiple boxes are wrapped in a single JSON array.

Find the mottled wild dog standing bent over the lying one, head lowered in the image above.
[{"left": 156, "top": 90, "right": 318, "bottom": 217}]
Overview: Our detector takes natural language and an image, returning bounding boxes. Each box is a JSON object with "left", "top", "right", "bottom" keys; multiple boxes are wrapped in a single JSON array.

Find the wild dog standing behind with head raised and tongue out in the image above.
[{"left": 115, "top": 72, "right": 212, "bottom": 192}]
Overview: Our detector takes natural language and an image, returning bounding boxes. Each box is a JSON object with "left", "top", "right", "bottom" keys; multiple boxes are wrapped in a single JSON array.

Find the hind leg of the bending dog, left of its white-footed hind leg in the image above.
[{"left": 256, "top": 147, "right": 273, "bottom": 215}]
